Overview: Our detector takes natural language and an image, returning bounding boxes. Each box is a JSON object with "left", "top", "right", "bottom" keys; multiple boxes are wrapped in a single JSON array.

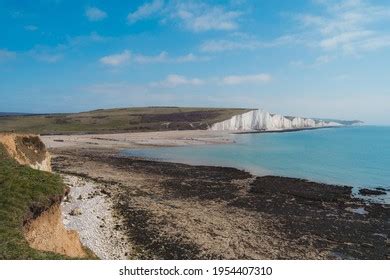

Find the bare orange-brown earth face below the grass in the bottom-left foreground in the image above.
[{"left": 24, "top": 204, "right": 87, "bottom": 258}]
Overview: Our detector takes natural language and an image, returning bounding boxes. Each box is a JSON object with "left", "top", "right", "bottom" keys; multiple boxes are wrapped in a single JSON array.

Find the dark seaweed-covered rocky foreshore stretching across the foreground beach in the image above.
[{"left": 52, "top": 148, "right": 390, "bottom": 259}]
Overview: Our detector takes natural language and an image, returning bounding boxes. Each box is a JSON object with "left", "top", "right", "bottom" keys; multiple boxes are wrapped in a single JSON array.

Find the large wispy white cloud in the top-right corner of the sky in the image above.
[{"left": 296, "top": 0, "right": 390, "bottom": 55}]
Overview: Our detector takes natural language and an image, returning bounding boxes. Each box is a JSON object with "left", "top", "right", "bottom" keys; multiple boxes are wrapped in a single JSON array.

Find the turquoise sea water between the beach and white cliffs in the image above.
[{"left": 125, "top": 126, "right": 390, "bottom": 203}]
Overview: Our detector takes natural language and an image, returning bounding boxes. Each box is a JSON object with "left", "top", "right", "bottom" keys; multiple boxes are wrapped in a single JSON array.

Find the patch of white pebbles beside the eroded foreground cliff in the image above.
[{"left": 61, "top": 175, "right": 130, "bottom": 260}]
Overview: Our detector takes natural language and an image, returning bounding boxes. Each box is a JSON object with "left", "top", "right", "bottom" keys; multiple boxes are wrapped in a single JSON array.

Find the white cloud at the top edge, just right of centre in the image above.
[{"left": 172, "top": 2, "right": 242, "bottom": 32}]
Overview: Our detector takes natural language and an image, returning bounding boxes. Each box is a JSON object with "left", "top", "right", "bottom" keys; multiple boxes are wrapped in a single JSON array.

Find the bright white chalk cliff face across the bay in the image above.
[{"left": 210, "top": 109, "right": 341, "bottom": 131}]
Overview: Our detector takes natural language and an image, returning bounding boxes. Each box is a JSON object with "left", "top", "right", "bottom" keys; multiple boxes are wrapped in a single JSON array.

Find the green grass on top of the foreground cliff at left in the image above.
[{"left": 0, "top": 144, "right": 65, "bottom": 259}]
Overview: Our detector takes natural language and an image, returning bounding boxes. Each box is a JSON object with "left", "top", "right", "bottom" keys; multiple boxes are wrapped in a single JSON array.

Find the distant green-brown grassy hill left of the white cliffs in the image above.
[{"left": 0, "top": 107, "right": 248, "bottom": 134}]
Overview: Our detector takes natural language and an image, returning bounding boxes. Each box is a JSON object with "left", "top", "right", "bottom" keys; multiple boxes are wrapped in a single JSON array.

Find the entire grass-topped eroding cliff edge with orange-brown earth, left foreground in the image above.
[{"left": 0, "top": 133, "right": 89, "bottom": 259}]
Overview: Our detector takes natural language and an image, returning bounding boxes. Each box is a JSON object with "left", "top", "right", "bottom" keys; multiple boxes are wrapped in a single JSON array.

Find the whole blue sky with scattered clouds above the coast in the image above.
[{"left": 0, "top": 0, "right": 390, "bottom": 124}]
